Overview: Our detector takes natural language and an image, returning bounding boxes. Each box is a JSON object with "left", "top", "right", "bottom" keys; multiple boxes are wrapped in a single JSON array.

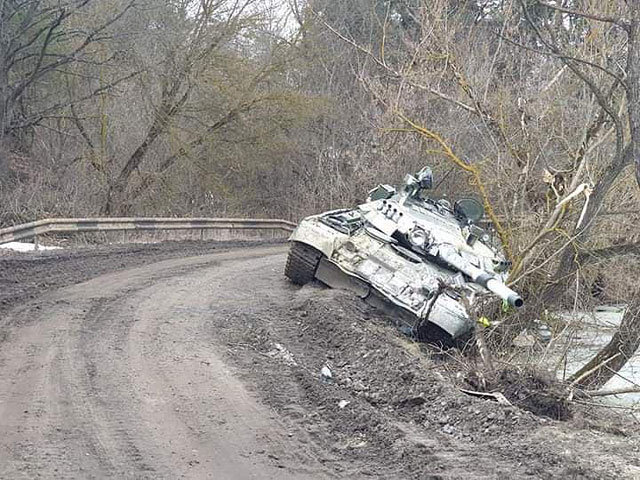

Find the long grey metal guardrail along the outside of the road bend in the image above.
[{"left": 0, "top": 217, "right": 296, "bottom": 244}]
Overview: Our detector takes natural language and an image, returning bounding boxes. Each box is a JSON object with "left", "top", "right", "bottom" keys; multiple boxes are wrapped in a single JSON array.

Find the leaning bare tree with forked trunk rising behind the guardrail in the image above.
[{"left": 103, "top": 0, "right": 290, "bottom": 214}]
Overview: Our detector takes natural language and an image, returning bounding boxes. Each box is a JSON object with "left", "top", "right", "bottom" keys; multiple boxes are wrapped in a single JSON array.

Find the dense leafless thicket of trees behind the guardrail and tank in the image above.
[{"left": 0, "top": 0, "right": 640, "bottom": 385}]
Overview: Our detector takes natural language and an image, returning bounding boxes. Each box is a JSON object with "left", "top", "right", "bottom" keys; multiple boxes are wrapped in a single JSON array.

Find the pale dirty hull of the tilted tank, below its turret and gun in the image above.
[{"left": 289, "top": 216, "right": 473, "bottom": 343}]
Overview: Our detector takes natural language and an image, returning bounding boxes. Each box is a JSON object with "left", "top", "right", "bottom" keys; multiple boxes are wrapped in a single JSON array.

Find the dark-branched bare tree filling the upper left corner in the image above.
[{"left": 0, "top": 0, "right": 137, "bottom": 142}]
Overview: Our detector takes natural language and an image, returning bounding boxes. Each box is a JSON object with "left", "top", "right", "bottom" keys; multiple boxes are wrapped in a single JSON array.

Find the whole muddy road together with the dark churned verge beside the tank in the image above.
[{"left": 0, "top": 245, "right": 640, "bottom": 479}]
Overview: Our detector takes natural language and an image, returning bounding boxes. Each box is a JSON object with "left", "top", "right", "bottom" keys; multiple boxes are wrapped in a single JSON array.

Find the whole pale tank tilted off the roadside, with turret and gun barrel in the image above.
[{"left": 285, "top": 167, "right": 523, "bottom": 344}]
